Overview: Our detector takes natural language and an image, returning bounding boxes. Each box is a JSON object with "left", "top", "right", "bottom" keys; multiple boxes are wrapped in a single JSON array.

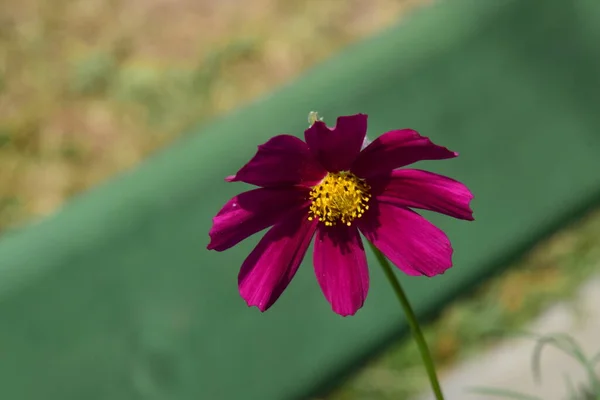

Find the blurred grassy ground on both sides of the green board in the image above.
[{"left": 0, "top": 0, "right": 600, "bottom": 399}]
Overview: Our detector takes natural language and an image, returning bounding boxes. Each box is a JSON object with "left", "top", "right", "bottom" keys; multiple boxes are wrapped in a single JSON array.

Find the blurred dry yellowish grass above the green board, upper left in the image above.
[{"left": 0, "top": 0, "right": 425, "bottom": 232}]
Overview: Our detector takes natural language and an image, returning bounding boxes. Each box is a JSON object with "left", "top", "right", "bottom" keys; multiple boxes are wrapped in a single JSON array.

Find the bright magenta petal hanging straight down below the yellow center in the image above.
[{"left": 313, "top": 225, "right": 369, "bottom": 316}]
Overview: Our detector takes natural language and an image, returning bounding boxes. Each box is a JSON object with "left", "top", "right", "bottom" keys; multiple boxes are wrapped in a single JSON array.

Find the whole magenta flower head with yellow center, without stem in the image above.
[{"left": 208, "top": 114, "right": 473, "bottom": 316}]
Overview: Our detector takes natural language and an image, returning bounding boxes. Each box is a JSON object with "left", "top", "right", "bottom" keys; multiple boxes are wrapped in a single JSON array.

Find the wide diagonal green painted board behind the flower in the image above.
[{"left": 0, "top": 0, "right": 600, "bottom": 400}]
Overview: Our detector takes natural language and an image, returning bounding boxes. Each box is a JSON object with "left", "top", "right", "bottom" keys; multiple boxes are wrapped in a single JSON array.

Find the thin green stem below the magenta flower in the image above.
[{"left": 369, "top": 243, "right": 444, "bottom": 400}]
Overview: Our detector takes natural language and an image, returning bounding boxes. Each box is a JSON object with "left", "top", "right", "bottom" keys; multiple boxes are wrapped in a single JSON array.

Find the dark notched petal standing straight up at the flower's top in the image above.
[{"left": 304, "top": 114, "right": 367, "bottom": 172}]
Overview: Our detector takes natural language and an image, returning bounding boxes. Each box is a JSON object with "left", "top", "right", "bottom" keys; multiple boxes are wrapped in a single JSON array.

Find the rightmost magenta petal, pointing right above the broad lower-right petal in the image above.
[{"left": 369, "top": 169, "right": 473, "bottom": 221}]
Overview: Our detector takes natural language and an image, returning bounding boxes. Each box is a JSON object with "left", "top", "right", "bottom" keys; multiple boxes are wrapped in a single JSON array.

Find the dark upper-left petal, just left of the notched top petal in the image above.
[{"left": 226, "top": 135, "right": 327, "bottom": 187}]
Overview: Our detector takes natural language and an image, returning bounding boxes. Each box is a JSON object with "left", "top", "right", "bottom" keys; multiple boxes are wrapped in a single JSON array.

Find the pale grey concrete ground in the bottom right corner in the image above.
[{"left": 420, "top": 277, "right": 600, "bottom": 400}]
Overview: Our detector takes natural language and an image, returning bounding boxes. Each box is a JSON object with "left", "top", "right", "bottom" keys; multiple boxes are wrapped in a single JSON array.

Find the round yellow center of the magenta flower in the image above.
[{"left": 308, "top": 172, "right": 371, "bottom": 226}]
